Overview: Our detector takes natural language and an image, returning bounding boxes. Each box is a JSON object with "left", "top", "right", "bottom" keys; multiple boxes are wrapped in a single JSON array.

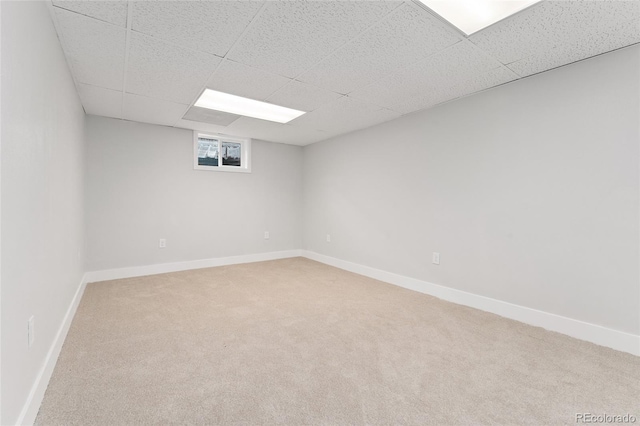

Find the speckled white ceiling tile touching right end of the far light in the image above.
[{"left": 290, "top": 96, "right": 400, "bottom": 134}]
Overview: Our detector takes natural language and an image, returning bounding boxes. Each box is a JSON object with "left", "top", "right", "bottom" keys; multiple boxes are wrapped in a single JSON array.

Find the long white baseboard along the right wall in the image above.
[{"left": 301, "top": 250, "right": 640, "bottom": 356}]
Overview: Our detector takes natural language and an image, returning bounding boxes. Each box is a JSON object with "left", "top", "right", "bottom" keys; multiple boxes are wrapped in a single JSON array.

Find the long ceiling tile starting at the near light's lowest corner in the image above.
[{"left": 351, "top": 41, "right": 501, "bottom": 109}]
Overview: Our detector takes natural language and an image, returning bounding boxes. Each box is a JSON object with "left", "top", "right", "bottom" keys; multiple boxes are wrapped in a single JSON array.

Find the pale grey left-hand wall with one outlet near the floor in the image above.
[{"left": 0, "top": 2, "right": 84, "bottom": 425}]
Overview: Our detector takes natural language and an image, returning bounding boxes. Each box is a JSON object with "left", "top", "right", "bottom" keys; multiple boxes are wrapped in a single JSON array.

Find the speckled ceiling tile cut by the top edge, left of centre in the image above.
[{"left": 132, "top": 1, "right": 263, "bottom": 56}]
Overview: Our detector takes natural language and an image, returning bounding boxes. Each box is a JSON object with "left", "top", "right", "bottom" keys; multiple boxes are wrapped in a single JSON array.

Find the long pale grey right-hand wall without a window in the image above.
[{"left": 303, "top": 46, "right": 640, "bottom": 335}]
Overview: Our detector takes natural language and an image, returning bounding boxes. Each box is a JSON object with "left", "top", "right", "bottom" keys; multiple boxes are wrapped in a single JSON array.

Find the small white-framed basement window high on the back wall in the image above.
[{"left": 193, "top": 131, "right": 251, "bottom": 173}]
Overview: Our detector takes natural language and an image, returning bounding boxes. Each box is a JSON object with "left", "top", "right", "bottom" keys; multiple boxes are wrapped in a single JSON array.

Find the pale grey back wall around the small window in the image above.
[{"left": 86, "top": 116, "right": 302, "bottom": 271}]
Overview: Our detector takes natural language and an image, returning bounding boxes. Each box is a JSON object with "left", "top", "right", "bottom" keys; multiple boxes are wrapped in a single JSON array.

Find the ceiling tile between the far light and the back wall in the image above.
[{"left": 227, "top": 117, "right": 330, "bottom": 145}]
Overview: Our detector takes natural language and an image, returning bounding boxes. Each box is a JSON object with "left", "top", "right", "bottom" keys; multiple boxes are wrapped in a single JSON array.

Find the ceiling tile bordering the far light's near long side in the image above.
[{"left": 207, "top": 60, "right": 290, "bottom": 101}]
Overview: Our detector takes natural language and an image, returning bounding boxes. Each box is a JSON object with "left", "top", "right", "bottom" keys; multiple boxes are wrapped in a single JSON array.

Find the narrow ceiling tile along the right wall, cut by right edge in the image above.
[{"left": 508, "top": 16, "right": 640, "bottom": 77}]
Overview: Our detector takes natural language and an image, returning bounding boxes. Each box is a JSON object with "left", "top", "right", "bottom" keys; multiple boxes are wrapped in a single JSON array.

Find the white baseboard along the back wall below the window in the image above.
[{"left": 86, "top": 250, "right": 301, "bottom": 283}]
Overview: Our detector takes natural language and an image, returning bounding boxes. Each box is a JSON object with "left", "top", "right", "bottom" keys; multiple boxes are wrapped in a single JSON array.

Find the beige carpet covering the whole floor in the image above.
[{"left": 37, "top": 258, "right": 640, "bottom": 425}]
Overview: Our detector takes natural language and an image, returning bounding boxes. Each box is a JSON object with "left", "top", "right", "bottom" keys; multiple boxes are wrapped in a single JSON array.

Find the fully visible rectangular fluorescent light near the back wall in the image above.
[{"left": 195, "top": 89, "right": 305, "bottom": 123}]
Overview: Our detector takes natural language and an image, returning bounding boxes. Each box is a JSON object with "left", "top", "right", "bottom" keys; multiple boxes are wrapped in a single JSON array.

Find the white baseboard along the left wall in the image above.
[{"left": 16, "top": 274, "right": 87, "bottom": 425}]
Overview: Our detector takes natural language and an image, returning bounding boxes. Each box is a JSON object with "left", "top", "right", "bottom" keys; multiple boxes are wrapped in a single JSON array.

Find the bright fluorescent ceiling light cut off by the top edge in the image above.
[{"left": 420, "top": 0, "right": 540, "bottom": 35}]
